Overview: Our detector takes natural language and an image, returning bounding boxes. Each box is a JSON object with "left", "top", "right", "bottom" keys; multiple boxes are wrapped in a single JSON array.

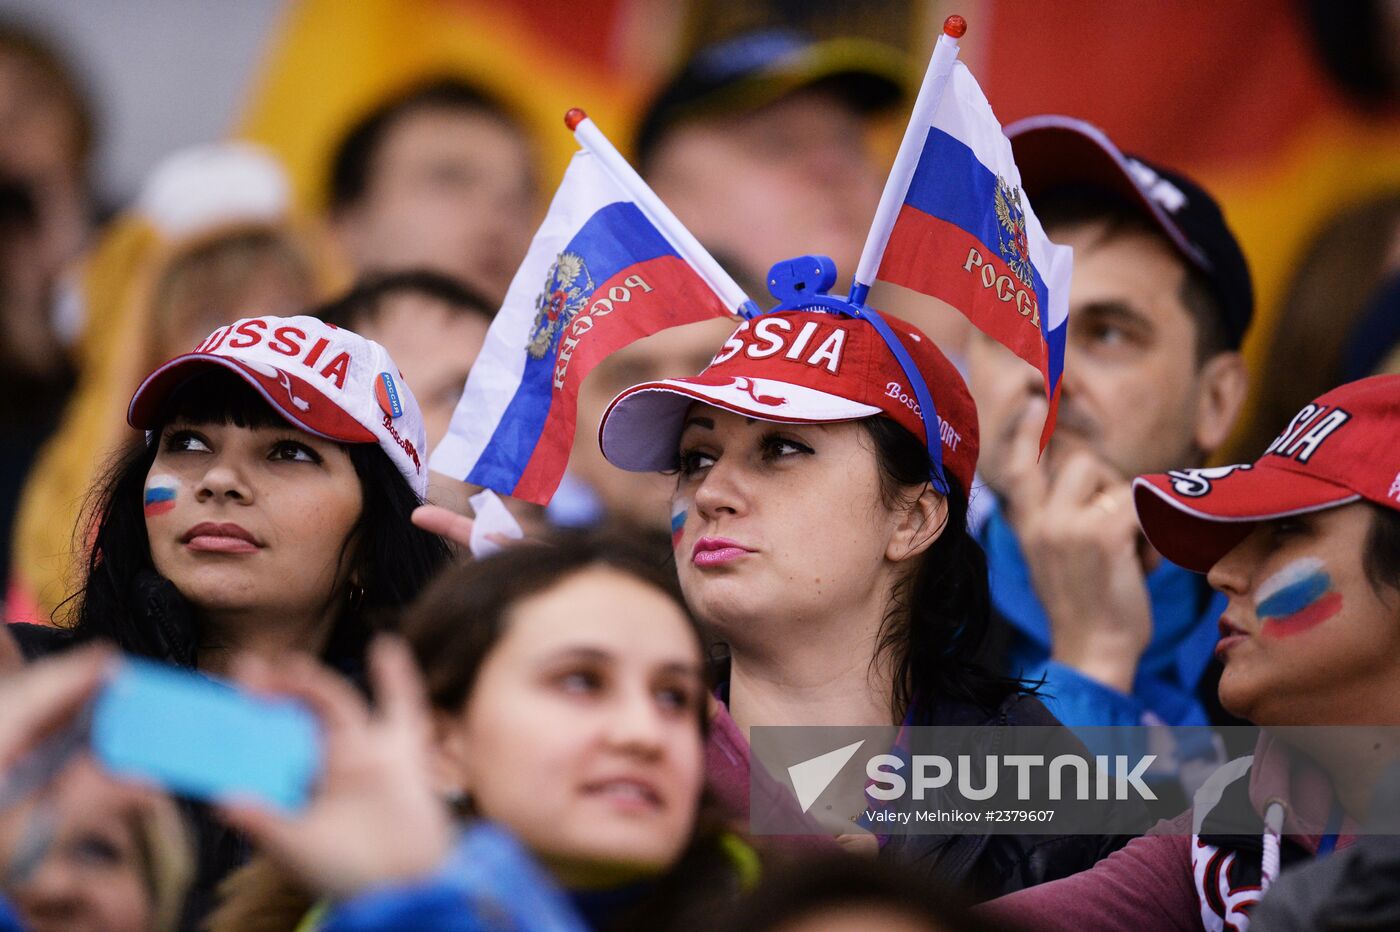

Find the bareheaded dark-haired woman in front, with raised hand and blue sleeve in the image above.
[{"left": 213, "top": 536, "right": 755, "bottom": 932}]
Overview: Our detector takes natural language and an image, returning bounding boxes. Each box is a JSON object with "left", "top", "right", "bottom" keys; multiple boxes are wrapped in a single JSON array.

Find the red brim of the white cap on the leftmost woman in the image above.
[{"left": 126, "top": 353, "right": 378, "bottom": 444}]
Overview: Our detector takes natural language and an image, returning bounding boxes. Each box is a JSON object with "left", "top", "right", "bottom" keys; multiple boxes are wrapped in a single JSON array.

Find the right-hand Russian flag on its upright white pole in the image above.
[{"left": 857, "top": 28, "right": 1072, "bottom": 448}]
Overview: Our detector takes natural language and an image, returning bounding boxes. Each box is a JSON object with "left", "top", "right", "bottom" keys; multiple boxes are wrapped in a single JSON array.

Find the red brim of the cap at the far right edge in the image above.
[{"left": 1133, "top": 463, "right": 1361, "bottom": 572}]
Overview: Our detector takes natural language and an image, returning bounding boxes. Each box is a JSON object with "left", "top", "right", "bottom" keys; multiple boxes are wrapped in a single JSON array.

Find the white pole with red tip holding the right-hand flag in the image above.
[{"left": 850, "top": 15, "right": 967, "bottom": 305}]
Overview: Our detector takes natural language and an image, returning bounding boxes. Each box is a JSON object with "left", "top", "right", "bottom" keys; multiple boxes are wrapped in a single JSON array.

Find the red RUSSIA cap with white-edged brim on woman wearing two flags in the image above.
[{"left": 598, "top": 311, "right": 977, "bottom": 493}]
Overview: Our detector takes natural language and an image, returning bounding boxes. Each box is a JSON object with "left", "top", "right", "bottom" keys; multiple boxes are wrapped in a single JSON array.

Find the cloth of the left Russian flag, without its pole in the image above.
[{"left": 430, "top": 137, "right": 731, "bottom": 505}]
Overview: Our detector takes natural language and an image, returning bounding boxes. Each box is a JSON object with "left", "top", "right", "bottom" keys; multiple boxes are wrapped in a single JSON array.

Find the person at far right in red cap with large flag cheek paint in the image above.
[{"left": 987, "top": 375, "right": 1400, "bottom": 932}]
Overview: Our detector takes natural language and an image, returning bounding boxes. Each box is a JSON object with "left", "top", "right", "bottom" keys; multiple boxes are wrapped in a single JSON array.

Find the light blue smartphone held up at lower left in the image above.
[{"left": 91, "top": 658, "right": 321, "bottom": 810}]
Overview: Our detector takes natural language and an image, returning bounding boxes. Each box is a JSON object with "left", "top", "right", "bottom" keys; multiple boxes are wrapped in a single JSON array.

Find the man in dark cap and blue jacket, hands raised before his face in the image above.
[{"left": 969, "top": 116, "right": 1253, "bottom": 725}]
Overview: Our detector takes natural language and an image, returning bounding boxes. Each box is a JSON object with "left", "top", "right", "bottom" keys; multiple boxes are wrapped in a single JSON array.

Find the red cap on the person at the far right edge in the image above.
[{"left": 1133, "top": 375, "right": 1400, "bottom": 572}]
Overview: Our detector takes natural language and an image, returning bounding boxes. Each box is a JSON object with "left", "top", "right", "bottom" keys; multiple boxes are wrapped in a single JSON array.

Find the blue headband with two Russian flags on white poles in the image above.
[{"left": 431, "top": 17, "right": 1072, "bottom": 505}]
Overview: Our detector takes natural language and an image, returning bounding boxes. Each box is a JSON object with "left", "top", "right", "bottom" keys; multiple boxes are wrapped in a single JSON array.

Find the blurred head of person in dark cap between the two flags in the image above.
[{"left": 637, "top": 29, "right": 907, "bottom": 280}]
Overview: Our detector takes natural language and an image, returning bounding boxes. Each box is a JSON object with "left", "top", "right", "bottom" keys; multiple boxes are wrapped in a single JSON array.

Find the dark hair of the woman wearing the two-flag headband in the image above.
[{"left": 860, "top": 417, "right": 1033, "bottom": 723}]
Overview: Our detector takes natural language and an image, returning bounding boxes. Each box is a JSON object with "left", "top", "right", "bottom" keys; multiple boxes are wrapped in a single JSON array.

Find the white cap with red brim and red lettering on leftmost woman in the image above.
[{"left": 126, "top": 316, "right": 428, "bottom": 498}]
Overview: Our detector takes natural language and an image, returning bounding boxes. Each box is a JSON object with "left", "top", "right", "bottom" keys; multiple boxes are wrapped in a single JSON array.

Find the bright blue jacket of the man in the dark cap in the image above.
[{"left": 977, "top": 492, "right": 1225, "bottom": 728}]
